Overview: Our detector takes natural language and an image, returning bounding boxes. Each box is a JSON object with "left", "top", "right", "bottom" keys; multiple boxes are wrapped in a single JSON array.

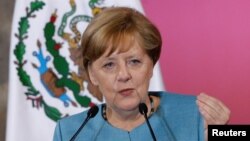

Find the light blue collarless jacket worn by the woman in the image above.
[{"left": 53, "top": 92, "right": 204, "bottom": 141}]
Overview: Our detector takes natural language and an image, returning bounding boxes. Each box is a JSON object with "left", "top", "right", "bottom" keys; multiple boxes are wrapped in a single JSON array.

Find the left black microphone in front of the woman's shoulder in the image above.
[{"left": 70, "top": 106, "right": 99, "bottom": 141}]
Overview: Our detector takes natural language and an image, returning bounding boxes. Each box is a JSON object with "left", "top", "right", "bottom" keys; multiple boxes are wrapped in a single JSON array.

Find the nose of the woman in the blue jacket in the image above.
[{"left": 117, "top": 65, "right": 131, "bottom": 82}]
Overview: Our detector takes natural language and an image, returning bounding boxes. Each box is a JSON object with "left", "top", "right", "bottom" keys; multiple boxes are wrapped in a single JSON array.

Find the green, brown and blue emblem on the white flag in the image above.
[{"left": 13, "top": 0, "right": 104, "bottom": 121}]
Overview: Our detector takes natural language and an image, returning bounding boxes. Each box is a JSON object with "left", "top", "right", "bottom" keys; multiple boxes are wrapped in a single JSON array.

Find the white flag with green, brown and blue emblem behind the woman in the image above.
[{"left": 6, "top": 0, "right": 164, "bottom": 141}]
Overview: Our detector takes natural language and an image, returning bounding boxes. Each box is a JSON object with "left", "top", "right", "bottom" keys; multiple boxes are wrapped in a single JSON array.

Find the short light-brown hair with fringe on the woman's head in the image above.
[{"left": 81, "top": 7, "right": 162, "bottom": 71}]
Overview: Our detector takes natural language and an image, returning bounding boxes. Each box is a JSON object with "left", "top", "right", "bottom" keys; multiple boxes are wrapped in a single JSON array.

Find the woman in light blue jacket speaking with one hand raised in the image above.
[{"left": 54, "top": 7, "right": 229, "bottom": 141}]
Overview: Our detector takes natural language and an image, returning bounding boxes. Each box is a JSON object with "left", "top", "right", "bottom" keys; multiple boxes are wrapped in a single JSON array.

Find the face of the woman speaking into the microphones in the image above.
[{"left": 89, "top": 43, "right": 153, "bottom": 111}]
